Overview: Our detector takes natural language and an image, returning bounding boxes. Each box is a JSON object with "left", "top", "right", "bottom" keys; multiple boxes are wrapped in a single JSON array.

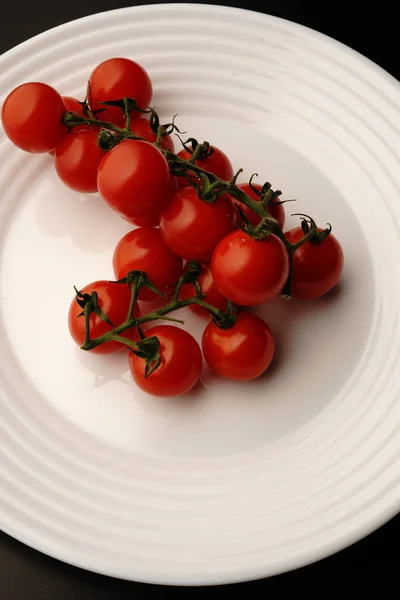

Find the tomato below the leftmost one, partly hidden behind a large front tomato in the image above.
[{"left": 54, "top": 129, "right": 105, "bottom": 194}]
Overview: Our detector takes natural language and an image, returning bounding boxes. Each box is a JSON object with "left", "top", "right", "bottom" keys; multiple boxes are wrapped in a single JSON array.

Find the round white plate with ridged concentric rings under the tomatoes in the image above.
[{"left": 0, "top": 4, "right": 400, "bottom": 584}]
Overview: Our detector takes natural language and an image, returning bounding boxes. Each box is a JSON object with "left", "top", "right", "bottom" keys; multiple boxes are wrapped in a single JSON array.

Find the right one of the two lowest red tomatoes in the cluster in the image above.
[{"left": 201, "top": 313, "right": 275, "bottom": 381}]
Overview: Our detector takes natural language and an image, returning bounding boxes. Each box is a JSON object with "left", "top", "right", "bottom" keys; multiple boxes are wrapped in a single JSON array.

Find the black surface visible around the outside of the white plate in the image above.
[{"left": 0, "top": 0, "right": 400, "bottom": 600}]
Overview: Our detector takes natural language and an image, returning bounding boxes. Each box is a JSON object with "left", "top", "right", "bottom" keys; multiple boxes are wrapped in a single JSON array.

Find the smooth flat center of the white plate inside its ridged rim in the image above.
[{"left": 1, "top": 116, "right": 374, "bottom": 457}]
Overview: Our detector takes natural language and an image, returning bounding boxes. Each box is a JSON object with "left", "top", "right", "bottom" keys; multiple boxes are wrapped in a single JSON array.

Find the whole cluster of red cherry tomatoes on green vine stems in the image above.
[{"left": 2, "top": 58, "right": 343, "bottom": 396}]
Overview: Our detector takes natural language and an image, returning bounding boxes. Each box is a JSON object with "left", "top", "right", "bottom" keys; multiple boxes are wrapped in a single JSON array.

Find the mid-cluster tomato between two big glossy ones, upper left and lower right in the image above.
[{"left": 160, "top": 186, "right": 235, "bottom": 262}]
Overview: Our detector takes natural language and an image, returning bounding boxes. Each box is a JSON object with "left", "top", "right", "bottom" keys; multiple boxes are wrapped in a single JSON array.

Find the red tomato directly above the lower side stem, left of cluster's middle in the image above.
[{"left": 113, "top": 227, "right": 183, "bottom": 301}]
